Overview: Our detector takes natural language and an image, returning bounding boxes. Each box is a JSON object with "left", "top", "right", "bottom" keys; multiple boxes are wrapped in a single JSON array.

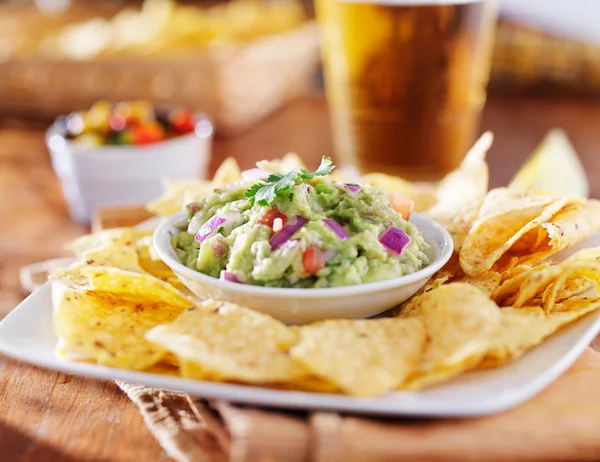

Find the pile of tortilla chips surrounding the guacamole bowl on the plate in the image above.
[{"left": 52, "top": 134, "right": 600, "bottom": 397}]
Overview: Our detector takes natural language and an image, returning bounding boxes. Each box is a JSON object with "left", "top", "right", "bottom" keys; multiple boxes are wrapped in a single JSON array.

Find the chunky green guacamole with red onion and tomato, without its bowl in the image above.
[{"left": 172, "top": 157, "right": 430, "bottom": 288}]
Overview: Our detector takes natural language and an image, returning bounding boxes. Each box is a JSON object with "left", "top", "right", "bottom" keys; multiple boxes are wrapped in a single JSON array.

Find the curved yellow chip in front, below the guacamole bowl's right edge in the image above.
[{"left": 401, "top": 283, "right": 500, "bottom": 390}]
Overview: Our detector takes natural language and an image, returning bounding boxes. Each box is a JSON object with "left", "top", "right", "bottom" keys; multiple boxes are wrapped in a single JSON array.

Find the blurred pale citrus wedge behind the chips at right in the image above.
[{"left": 508, "top": 129, "right": 590, "bottom": 197}]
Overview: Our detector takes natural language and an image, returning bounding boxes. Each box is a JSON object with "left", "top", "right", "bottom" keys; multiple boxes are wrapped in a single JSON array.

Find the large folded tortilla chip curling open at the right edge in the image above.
[{"left": 460, "top": 189, "right": 600, "bottom": 277}]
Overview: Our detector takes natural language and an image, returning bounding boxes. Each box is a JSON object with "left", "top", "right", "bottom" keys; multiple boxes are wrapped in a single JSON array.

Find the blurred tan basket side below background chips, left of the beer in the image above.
[{"left": 0, "top": 21, "right": 319, "bottom": 135}]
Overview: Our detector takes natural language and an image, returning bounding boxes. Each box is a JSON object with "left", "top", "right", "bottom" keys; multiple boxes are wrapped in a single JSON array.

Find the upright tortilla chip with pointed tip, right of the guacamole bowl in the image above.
[{"left": 425, "top": 132, "right": 494, "bottom": 252}]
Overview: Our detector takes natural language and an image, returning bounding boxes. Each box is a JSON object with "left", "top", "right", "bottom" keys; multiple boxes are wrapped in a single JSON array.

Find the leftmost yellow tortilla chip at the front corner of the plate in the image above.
[{"left": 52, "top": 283, "right": 183, "bottom": 370}]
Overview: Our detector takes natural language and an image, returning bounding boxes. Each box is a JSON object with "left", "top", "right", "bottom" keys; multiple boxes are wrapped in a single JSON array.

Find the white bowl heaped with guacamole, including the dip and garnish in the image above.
[{"left": 155, "top": 157, "right": 452, "bottom": 322}]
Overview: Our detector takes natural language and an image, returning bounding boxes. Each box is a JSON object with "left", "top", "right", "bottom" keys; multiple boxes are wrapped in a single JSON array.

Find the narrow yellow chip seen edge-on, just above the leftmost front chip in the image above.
[{"left": 80, "top": 266, "right": 194, "bottom": 308}]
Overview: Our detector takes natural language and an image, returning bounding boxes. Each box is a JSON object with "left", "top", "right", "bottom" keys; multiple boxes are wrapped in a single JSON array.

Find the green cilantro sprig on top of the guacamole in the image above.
[{"left": 246, "top": 157, "right": 335, "bottom": 206}]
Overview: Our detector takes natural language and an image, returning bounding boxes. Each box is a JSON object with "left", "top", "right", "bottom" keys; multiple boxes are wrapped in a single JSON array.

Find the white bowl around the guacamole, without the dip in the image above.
[{"left": 154, "top": 212, "right": 452, "bottom": 324}]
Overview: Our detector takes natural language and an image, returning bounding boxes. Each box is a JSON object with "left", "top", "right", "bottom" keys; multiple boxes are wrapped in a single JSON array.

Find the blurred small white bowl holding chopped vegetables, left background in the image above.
[{"left": 46, "top": 114, "right": 213, "bottom": 223}]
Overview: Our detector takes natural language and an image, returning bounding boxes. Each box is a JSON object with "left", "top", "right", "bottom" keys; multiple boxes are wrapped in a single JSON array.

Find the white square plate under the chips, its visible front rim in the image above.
[{"left": 0, "top": 284, "right": 600, "bottom": 417}]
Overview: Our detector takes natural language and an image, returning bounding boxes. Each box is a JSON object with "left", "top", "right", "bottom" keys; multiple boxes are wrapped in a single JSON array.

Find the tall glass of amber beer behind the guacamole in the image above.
[{"left": 315, "top": 0, "right": 497, "bottom": 180}]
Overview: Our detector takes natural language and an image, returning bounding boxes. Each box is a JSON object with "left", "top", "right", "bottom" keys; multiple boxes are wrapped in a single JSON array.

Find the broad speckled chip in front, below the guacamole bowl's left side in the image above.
[{"left": 146, "top": 300, "right": 308, "bottom": 383}]
